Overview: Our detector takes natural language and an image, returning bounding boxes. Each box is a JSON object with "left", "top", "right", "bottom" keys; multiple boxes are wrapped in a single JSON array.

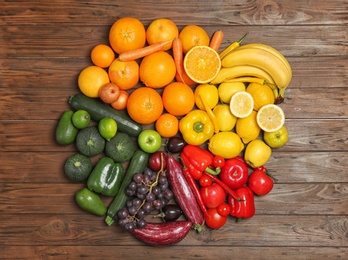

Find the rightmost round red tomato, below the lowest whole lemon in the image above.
[{"left": 248, "top": 170, "right": 274, "bottom": 196}]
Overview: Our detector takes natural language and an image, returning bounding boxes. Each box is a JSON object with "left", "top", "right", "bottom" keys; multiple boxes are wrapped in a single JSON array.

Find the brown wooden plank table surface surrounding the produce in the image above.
[{"left": 0, "top": 0, "right": 348, "bottom": 259}]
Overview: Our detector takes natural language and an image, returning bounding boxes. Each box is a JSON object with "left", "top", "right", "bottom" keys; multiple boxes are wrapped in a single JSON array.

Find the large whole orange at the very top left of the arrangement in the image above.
[{"left": 109, "top": 17, "right": 146, "bottom": 54}]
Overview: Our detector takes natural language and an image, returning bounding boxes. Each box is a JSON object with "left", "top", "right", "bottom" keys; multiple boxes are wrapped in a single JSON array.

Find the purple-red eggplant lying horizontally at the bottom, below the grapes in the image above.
[{"left": 132, "top": 221, "right": 192, "bottom": 246}]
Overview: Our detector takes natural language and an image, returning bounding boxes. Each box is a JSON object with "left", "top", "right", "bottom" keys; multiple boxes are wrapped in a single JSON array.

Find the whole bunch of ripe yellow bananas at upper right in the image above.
[{"left": 211, "top": 40, "right": 292, "bottom": 104}]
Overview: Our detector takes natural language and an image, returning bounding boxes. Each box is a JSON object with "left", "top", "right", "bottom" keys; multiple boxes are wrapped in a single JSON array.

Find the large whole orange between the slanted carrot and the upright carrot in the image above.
[{"left": 139, "top": 51, "right": 176, "bottom": 88}]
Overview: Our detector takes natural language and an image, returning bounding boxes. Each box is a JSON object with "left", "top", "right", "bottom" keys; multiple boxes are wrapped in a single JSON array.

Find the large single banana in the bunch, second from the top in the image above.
[{"left": 221, "top": 48, "right": 292, "bottom": 89}]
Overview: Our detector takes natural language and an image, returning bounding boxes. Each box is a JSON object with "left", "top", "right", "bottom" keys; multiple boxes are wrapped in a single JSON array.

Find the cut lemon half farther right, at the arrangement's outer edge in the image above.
[{"left": 256, "top": 104, "right": 285, "bottom": 132}]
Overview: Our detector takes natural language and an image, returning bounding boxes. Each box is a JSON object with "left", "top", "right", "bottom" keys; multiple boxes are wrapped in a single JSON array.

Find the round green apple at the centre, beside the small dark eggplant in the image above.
[{"left": 138, "top": 129, "right": 162, "bottom": 153}]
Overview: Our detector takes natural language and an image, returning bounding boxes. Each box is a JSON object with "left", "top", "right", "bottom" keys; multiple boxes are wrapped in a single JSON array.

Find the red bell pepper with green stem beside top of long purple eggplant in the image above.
[{"left": 180, "top": 144, "right": 220, "bottom": 180}]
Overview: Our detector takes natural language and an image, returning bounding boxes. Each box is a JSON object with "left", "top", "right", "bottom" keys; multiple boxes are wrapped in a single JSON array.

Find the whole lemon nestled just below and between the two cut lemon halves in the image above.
[{"left": 236, "top": 111, "right": 261, "bottom": 144}]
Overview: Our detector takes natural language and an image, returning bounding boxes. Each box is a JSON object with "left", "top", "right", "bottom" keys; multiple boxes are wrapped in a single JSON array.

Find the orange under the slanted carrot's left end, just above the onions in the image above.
[{"left": 108, "top": 59, "right": 139, "bottom": 90}]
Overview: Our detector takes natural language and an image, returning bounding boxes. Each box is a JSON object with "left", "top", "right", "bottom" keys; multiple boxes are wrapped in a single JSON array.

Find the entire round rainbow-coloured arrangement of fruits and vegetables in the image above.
[{"left": 56, "top": 17, "right": 292, "bottom": 246}]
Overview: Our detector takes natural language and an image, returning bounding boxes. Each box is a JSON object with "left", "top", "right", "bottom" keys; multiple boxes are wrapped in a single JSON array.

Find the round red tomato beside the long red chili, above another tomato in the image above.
[{"left": 200, "top": 182, "right": 226, "bottom": 208}]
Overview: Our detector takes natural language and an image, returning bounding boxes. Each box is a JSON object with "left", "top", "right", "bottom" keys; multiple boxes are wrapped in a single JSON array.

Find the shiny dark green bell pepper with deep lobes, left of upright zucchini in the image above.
[{"left": 87, "top": 156, "right": 124, "bottom": 196}]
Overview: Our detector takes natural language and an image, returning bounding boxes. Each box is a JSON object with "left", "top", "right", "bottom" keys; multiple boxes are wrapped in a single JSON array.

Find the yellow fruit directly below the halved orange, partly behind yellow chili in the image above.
[{"left": 194, "top": 84, "right": 219, "bottom": 110}]
